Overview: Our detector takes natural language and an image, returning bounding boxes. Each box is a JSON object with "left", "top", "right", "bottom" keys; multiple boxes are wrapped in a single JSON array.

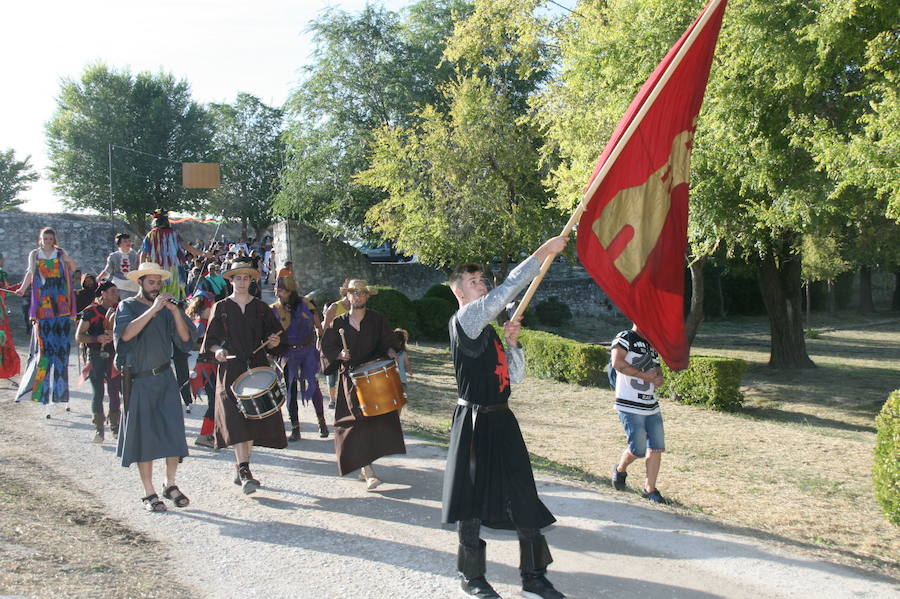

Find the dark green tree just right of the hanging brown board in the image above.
[{"left": 209, "top": 93, "right": 284, "bottom": 238}]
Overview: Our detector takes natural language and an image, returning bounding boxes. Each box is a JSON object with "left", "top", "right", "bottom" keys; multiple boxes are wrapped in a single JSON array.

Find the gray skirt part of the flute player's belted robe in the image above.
[{"left": 116, "top": 370, "right": 188, "bottom": 467}]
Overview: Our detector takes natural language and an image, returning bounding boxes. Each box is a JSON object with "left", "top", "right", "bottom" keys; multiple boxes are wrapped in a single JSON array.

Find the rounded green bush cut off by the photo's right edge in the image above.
[{"left": 872, "top": 389, "right": 900, "bottom": 525}]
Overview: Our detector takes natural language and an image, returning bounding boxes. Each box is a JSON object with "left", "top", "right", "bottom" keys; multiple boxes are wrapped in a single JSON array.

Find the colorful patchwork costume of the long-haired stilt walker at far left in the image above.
[{"left": 16, "top": 248, "right": 75, "bottom": 404}]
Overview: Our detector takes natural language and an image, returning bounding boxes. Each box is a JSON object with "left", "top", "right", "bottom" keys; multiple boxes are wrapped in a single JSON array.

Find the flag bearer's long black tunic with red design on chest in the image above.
[{"left": 442, "top": 262, "right": 556, "bottom": 530}]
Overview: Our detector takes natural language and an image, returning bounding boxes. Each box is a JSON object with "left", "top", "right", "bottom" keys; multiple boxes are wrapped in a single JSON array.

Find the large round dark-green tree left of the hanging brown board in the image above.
[{"left": 47, "top": 63, "right": 212, "bottom": 233}]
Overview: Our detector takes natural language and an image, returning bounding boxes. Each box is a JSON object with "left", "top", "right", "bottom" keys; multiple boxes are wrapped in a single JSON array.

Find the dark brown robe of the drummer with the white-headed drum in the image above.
[{"left": 200, "top": 298, "right": 287, "bottom": 449}]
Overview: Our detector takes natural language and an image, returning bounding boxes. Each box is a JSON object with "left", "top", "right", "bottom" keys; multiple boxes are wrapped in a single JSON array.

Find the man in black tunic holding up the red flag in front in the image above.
[{"left": 442, "top": 236, "right": 567, "bottom": 599}]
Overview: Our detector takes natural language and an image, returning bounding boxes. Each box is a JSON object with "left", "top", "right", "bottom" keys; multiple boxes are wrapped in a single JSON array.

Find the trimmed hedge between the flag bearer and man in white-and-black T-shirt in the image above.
[{"left": 494, "top": 325, "right": 609, "bottom": 387}]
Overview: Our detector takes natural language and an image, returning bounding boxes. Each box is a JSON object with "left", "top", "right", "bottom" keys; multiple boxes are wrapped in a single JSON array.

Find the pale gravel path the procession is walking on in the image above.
[{"left": 0, "top": 360, "right": 900, "bottom": 599}]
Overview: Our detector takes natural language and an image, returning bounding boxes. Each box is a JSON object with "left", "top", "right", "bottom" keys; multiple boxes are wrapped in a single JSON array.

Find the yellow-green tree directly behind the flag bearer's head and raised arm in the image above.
[{"left": 358, "top": 77, "right": 563, "bottom": 279}]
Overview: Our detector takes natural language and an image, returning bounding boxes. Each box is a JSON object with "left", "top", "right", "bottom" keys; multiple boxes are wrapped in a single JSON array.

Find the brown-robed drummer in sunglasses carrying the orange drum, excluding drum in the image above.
[{"left": 322, "top": 279, "right": 406, "bottom": 491}]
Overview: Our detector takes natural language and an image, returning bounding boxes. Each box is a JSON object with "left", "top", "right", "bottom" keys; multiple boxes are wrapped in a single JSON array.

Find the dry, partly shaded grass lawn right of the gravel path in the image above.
[{"left": 403, "top": 314, "right": 900, "bottom": 575}]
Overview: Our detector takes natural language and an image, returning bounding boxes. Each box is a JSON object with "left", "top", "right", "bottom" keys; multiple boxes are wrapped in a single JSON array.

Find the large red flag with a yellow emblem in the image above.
[{"left": 577, "top": 0, "right": 726, "bottom": 370}]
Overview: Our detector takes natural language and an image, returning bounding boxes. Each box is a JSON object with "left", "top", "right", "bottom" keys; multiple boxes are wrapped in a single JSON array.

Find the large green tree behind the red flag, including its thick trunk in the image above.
[{"left": 540, "top": 0, "right": 891, "bottom": 368}]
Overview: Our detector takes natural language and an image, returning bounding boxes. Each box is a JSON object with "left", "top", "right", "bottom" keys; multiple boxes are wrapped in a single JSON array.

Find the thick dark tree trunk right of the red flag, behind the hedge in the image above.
[{"left": 759, "top": 250, "right": 815, "bottom": 368}]
